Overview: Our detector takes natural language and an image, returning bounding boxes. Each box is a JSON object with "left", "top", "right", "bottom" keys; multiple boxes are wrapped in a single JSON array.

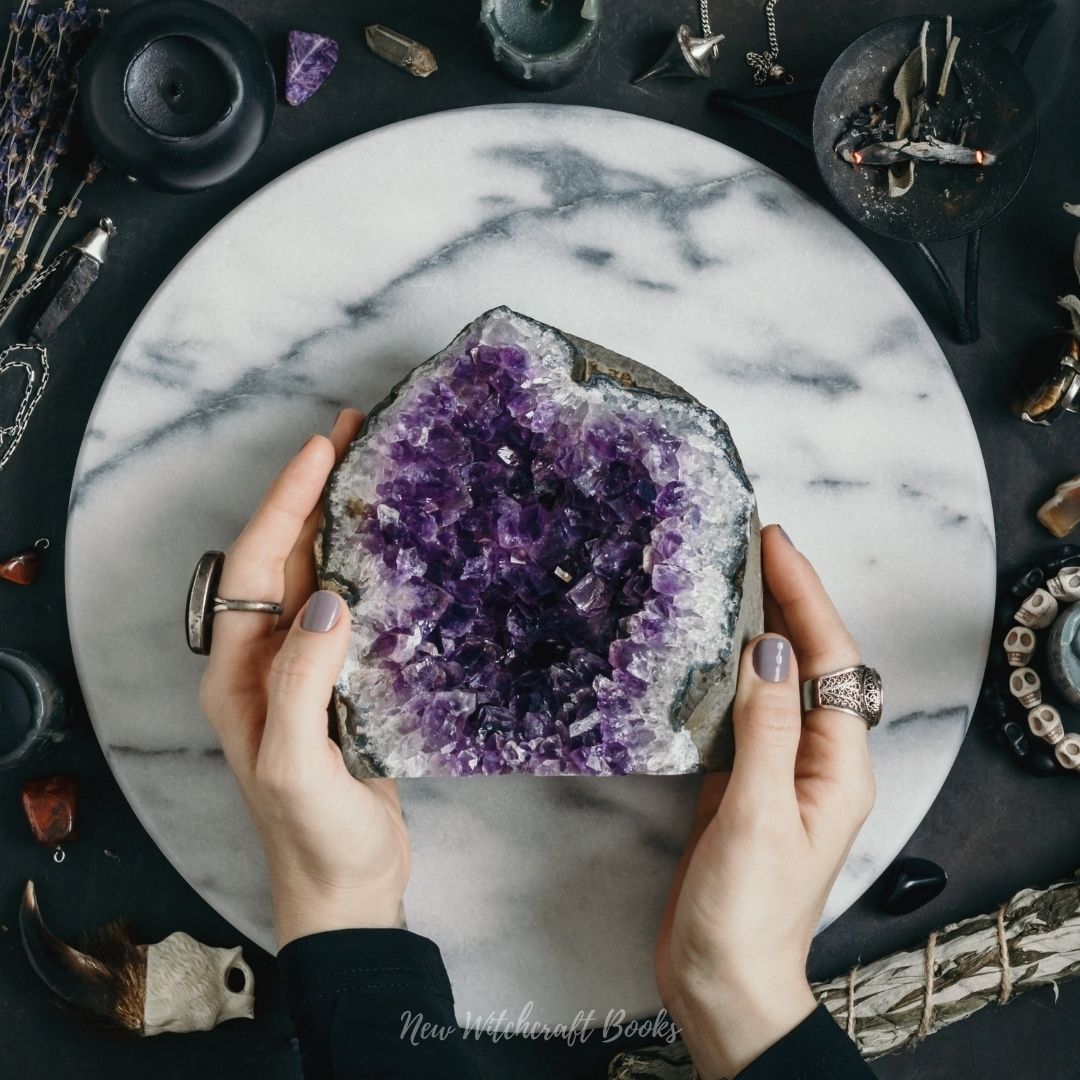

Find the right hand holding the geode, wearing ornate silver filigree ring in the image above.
[{"left": 656, "top": 525, "right": 874, "bottom": 1080}]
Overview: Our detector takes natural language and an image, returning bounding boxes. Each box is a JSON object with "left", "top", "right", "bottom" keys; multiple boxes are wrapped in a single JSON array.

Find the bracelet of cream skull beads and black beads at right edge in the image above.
[{"left": 1001, "top": 545, "right": 1080, "bottom": 772}]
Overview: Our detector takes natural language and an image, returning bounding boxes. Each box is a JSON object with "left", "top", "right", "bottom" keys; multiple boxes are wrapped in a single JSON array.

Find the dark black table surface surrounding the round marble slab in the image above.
[{"left": 0, "top": 0, "right": 1080, "bottom": 1080}]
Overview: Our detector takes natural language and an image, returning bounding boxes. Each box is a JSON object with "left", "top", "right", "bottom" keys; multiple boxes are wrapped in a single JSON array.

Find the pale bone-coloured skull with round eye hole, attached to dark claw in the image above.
[{"left": 143, "top": 931, "right": 255, "bottom": 1035}]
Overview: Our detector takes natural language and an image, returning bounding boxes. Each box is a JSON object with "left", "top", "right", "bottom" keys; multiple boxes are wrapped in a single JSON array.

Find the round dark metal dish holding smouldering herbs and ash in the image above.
[{"left": 813, "top": 15, "right": 1039, "bottom": 244}]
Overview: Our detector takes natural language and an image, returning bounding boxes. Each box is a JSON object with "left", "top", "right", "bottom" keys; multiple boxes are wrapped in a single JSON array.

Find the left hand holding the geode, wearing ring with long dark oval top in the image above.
[{"left": 199, "top": 409, "right": 410, "bottom": 947}]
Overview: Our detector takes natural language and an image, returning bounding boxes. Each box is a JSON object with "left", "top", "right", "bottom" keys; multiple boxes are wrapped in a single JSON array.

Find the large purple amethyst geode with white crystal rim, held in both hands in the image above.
[{"left": 316, "top": 308, "right": 761, "bottom": 777}]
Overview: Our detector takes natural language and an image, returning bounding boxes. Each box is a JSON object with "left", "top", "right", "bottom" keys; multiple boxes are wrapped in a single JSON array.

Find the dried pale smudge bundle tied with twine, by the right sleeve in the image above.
[{"left": 608, "top": 870, "right": 1080, "bottom": 1080}]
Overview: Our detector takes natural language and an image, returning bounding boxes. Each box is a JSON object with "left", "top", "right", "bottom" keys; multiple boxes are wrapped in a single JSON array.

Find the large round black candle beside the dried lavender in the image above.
[{"left": 79, "top": 0, "right": 275, "bottom": 191}]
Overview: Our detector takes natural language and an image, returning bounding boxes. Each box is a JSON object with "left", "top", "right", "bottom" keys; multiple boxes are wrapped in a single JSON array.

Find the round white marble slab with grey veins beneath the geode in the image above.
[{"left": 67, "top": 105, "right": 995, "bottom": 1023}]
